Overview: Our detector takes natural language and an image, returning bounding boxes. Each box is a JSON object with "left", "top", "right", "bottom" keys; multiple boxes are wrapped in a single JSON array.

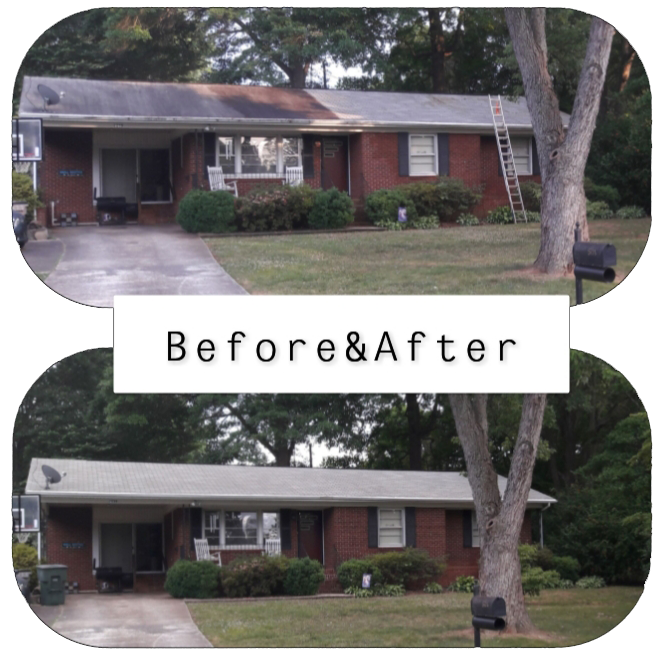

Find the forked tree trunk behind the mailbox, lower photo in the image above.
[{"left": 449, "top": 394, "right": 547, "bottom": 632}]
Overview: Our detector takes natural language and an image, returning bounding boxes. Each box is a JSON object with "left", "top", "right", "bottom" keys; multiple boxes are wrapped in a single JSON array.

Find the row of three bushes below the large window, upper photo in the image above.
[{"left": 176, "top": 185, "right": 354, "bottom": 233}]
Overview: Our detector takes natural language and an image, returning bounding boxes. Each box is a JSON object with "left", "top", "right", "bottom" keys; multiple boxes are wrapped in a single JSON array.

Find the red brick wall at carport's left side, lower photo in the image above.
[{"left": 46, "top": 506, "right": 96, "bottom": 590}]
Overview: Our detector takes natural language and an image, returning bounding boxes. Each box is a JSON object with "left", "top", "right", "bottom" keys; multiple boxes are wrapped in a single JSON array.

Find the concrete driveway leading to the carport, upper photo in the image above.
[{"left": 34, "top": 225, "right": 247, "bottom": 308}]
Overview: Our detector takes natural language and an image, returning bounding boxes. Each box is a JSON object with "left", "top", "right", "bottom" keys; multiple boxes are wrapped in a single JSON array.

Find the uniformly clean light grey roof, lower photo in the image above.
[{"left": 26, "top": 458, "right": 554, "bottom": 504}]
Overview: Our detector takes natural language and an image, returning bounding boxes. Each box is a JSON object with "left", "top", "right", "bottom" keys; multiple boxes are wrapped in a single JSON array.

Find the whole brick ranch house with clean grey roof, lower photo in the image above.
[{"left": 25, "top": 458, "right": 555, "bottom": 592}]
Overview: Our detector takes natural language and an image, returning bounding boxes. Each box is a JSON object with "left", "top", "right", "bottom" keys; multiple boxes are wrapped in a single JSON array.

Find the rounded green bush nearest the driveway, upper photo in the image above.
[{"left": 176, "top": 190, "right": 237, "bottom": 233}]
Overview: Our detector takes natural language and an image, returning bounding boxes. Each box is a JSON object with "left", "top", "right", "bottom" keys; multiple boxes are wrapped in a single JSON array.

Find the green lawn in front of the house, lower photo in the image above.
[{"left": 189, "top": 587, "right": 642, "bottom": 647}]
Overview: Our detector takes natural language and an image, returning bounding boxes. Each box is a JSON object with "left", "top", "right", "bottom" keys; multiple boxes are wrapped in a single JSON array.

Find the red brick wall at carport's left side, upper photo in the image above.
[{"left": 37, "top": 129, "right": 96, "bottom": 226}]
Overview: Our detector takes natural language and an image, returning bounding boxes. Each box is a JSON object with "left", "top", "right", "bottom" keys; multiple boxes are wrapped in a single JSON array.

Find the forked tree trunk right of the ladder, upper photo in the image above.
[{"left": 505, "top": 8, "right": 614, "bottom": 274}]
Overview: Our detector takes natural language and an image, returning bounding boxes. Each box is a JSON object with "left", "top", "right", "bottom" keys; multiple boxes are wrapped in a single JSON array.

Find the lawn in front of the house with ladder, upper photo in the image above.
[{"left": 207, "top": 219, "right": 651, "bottom": 300}]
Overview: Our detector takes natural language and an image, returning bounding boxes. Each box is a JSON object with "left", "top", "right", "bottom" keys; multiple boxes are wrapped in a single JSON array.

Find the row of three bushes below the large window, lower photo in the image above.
[{"left": 164, "top": 556, "right": 324, "bottom": 599}]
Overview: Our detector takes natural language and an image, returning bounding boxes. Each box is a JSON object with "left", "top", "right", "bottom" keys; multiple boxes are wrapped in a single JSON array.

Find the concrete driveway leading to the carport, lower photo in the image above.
[{"left": 32, "top": 593, "right": 212, "bottom": 648}]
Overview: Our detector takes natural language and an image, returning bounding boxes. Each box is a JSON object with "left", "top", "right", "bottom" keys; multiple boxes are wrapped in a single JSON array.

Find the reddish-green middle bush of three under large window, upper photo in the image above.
[{"left": 236, "top": 185, "right": 317, "bottom": 232}]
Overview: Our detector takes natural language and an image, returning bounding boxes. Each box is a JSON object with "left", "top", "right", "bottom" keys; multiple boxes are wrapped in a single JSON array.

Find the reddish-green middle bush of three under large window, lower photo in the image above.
[{"left": 220, "top": 556, "right": 288, "bottom": 597}]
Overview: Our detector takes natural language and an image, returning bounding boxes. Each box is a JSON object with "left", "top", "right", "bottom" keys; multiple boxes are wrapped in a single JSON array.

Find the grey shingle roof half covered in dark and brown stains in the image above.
[{"left": 19, "top": 76, "right": 567, "bottom": 130}]
